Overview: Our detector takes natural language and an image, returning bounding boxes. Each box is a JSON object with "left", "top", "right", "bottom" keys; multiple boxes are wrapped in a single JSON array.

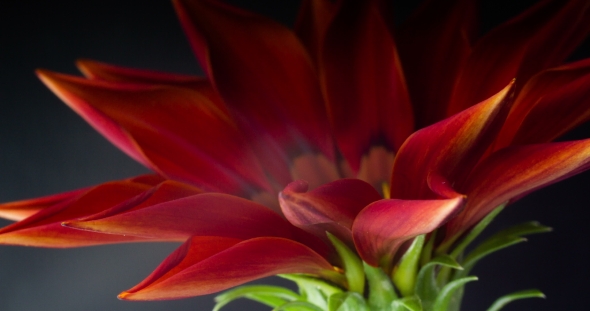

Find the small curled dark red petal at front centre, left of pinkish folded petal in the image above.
[{"left": 279, "top": 179, "right": 381, "bottom": 244}]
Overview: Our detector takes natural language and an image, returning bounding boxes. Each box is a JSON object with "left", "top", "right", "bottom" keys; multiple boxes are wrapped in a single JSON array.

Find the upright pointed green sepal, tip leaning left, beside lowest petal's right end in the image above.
[{"left": 326, "top": 232, "right": 365, "bottom": 295}]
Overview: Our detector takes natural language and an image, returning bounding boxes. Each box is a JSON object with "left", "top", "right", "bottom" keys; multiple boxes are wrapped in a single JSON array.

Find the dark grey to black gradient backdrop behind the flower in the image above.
[{"left": 0, "top": 0, "right": 590, "bottom": 311}]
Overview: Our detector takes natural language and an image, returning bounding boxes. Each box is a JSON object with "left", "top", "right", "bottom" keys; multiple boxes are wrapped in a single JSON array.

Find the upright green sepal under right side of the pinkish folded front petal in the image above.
[{"left": 392, "top": 235, "right": 424, "bottom": 297}]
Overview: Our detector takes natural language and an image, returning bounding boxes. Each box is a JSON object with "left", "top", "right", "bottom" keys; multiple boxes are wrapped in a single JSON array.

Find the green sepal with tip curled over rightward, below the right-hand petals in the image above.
[{"left": 415, "top": 255, "right": 463, "bottom": 310}]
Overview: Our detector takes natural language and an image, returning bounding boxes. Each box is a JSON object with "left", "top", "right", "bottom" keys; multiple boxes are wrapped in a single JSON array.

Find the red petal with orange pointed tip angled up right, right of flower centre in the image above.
[{"left": 391, "top": 85, "right": 513, "bottom": 199}]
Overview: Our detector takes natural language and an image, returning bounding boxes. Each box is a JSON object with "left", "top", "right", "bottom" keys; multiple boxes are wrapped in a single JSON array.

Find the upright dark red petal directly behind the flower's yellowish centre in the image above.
[{"left": 321, "top": 1, "right": 414, "bottom": 173}]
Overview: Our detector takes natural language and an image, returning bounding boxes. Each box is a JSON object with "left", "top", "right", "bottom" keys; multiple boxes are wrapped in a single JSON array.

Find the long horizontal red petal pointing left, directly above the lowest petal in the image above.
[{"left": 64, "top": 192, "right": 295, "bottom": 240}]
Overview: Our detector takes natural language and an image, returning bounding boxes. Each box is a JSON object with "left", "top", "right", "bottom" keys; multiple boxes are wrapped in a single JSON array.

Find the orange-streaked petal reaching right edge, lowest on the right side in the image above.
[{"left": 447, "top": 140, "right": 590, "bottom": 237}]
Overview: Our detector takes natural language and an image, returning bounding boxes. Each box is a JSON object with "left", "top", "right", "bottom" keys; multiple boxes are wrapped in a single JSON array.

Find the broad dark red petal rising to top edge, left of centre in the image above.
[{"left": 174, "top": 0, "right": 333, "bottom": 183}]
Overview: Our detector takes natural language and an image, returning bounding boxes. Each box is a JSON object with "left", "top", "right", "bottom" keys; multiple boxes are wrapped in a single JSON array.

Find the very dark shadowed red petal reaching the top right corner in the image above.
[{"left": 448, "top": 0, "right": 590, "bottom": 115}]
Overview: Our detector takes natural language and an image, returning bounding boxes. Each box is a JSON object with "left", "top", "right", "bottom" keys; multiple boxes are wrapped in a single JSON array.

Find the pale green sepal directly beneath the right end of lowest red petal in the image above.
[{"left": 277, "top": 274, "right": 342, "bottom": 309}]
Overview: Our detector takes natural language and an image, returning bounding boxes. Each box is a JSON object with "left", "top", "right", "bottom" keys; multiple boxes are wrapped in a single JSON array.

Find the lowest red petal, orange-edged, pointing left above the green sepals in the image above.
[{"left": 119, "top": 237, "right": 333, "bottom": 300}]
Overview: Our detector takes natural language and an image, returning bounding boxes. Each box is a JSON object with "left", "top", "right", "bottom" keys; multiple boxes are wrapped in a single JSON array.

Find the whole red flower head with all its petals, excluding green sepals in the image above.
[{"left": 0, "top": 0, "right": 590, "bottom": 300}]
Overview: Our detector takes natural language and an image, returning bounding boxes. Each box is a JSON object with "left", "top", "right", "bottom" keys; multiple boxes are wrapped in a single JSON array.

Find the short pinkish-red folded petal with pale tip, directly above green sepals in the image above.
[{"left": 352, "top": 197, "right": 465, "bottom": 270}]
